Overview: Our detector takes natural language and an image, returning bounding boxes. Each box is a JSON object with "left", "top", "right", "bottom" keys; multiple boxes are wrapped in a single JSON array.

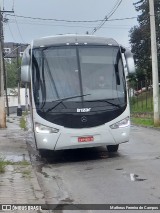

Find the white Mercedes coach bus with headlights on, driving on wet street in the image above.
[{"left": 21, "top": 35, "right": 135, "bottom": 154}]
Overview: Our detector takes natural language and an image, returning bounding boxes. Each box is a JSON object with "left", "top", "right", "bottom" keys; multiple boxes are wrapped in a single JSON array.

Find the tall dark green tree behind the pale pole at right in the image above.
[{"left": 130, "top": 0, "right": 160, "bottom": 80}]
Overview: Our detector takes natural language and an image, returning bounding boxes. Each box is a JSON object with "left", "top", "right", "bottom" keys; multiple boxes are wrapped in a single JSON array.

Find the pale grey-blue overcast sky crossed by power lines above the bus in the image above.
[{"left": 1, "top": 0, "right": 138, "bottom": 47}]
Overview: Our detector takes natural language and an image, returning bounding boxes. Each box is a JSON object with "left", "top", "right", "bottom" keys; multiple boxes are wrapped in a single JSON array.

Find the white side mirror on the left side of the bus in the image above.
[{"left": 21, "top": 46, "right": 31, "bottom": 83}]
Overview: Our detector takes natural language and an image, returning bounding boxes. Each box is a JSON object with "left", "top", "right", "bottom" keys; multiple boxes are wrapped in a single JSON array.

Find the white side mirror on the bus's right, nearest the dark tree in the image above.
[{"left": 124, "top": 49, "right": 135, "bottom": 74}]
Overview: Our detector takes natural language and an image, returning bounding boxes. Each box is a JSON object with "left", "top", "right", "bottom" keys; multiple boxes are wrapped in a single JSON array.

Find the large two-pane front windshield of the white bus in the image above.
[{"left": 32, "top": 45, "right": 126, "bottom": 106}]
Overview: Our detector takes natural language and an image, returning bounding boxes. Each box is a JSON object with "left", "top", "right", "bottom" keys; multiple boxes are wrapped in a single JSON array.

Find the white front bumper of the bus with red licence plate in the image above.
[{"left": 35, "top": 126, "right": 130, "bottom": 150}]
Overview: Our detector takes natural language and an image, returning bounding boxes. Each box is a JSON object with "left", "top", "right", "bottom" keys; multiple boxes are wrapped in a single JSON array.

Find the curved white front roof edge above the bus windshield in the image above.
[{"left": 32, "top": 34, "right": 119, "bottom": 48}]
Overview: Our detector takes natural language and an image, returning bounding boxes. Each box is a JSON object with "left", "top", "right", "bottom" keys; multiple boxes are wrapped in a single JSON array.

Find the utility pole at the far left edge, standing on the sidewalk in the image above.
[{"left": 0, "top": 5, "right": 6, "bottom": 128}]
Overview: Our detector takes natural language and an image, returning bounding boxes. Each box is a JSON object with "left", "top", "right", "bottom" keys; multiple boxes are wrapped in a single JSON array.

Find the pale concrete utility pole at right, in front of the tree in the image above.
[{"left": 149, "top": 0, "right": 160, "bottom": 126}]
